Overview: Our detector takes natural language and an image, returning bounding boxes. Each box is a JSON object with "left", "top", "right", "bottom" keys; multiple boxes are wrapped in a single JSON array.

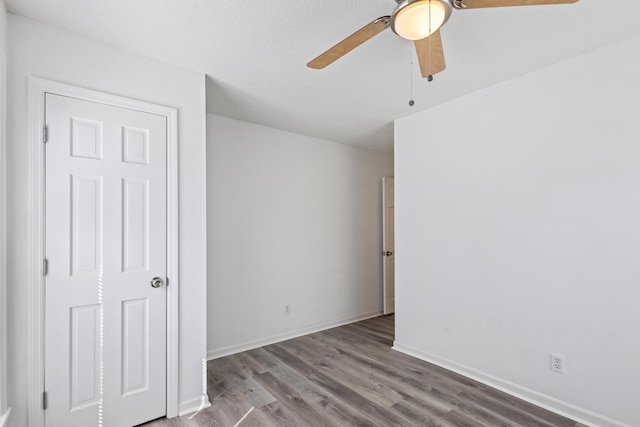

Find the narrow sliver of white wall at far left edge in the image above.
[{"left": 0, "top": 0, "right": 7, "bottom": 427}]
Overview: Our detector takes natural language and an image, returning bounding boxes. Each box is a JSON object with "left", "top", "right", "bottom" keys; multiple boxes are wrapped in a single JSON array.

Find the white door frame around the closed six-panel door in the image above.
[{"left": 27, "top": 77, "right": 180, "bottom": 427}]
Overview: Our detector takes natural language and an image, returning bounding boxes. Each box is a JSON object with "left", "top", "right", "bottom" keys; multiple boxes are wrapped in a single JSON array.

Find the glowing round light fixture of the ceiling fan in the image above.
[{"left": 391, "top": 0, "right": 452, "bottom": 40}]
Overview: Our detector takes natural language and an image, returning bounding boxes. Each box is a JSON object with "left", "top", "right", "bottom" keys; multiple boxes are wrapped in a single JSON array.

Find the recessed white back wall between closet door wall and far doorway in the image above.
[{"left": 207, "top": 115, "right": 393, "bottom": 358}]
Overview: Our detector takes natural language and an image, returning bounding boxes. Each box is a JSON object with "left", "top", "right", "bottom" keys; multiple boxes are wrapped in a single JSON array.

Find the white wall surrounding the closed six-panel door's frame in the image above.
[{"left": 7, "top": 15, "right": 207, "bottom": 427}]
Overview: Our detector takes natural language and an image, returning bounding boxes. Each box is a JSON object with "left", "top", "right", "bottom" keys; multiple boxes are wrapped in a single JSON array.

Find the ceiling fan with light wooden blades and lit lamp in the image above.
[{"left": 307, "top": 0, "right": 579, "bottom": 80}]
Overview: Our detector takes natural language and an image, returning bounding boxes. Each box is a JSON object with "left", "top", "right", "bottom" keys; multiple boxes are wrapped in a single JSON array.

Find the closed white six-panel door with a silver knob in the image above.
[{"left": 45, "top": 94, "right": 167, "bottom": 427}]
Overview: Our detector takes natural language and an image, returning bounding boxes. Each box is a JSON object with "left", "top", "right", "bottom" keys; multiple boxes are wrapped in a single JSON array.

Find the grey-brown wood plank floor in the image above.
[{"left": 143, "top": 316, "right": 582, "bottom": 427}]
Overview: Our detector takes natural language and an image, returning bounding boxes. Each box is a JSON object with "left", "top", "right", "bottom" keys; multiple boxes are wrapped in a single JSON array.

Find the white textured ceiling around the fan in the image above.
[{"left": 5, "top": 0, "right": 640, "bottom": 150}]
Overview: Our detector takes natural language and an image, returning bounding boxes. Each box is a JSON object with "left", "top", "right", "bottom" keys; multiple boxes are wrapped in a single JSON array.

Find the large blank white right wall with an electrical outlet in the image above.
[{"left": 395, "top": 37, "right": 640, "bottom": 426}]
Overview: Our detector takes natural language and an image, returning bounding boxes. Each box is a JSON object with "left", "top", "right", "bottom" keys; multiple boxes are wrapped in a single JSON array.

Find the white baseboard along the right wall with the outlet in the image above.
[{"left": 392, "top": 341, "right": 632, "bottom": 427}]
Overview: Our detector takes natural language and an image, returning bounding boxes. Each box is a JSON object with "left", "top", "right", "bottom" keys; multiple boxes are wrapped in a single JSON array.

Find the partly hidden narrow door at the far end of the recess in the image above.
[{"left": 382, "top": 178, "right": 396, "bottom": 314}]
